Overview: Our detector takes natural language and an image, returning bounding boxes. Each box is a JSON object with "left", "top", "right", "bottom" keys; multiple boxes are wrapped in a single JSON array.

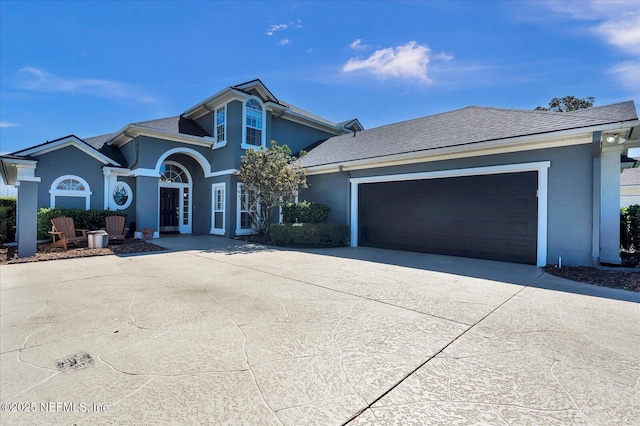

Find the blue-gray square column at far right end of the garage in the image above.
[{"left": 600, "top": 145, "right": 623, "bottom": 265}]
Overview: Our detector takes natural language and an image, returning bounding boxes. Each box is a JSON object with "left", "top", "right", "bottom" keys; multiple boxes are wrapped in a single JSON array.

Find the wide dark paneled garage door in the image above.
[{"left": 358, "top": 172, "right": 538, "bottom": 265}]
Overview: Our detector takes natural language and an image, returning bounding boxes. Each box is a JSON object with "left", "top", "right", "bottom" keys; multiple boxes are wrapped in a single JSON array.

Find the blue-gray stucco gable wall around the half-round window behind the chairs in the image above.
[{"left": 35, "top": 146, "right": 104, "bottom": 209}]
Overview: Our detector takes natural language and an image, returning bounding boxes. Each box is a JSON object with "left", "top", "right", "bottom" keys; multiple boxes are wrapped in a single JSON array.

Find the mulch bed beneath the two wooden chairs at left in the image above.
[{"left": 0, "top": 238, "right": 166, "bottom": 265}]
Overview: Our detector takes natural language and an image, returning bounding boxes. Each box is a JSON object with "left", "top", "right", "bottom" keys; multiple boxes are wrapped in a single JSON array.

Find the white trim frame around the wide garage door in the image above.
[{"left": 349, "top": 161, "right": 551, "bottom": 267}]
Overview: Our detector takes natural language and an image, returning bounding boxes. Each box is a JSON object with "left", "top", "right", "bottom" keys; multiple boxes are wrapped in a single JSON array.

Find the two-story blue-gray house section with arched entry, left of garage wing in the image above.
[{"left": 5, "top": 80, "right": 362, "bottom": 241}]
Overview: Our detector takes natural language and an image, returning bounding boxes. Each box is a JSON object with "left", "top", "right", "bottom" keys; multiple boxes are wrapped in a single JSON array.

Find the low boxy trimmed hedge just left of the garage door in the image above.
[{"left": 269, "top": 223, "right": 349, "bottom": 247}]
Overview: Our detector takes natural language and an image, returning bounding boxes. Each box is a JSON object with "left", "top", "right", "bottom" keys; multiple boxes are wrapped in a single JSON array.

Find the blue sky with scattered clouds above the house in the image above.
[{"left": 0, "top": 0, "right": 640, "bottom": 153}]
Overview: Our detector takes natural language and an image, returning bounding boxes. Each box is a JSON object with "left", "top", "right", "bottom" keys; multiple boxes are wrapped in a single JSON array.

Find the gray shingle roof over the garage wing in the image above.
[{"left": 302, "top": 101, "right": 638, "bottom": 167}]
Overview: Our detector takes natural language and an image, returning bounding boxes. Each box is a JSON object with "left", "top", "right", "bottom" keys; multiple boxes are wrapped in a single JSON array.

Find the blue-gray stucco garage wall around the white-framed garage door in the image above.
[{"left": 300, "top": 145, "right": 593, "bottom": 266}]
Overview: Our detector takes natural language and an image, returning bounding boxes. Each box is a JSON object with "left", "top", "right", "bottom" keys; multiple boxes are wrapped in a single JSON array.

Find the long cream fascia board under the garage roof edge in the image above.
[{"left": 306, "top": 120, "right": 638, "bottom": 175}]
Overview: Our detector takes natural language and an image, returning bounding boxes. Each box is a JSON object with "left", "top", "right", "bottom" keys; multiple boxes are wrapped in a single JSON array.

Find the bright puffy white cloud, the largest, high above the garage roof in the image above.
[{"left": 342, "top": 40, "right": 438, "bottom": 83}]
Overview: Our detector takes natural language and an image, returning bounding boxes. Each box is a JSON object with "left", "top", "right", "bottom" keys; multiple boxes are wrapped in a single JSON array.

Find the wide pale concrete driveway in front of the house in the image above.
[{"left": 0, "top": 237, "right": 640, "bottom": 425}]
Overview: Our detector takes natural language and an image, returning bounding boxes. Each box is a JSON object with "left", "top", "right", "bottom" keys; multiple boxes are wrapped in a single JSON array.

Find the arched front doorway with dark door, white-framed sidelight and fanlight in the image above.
[{"left": 158, "top": 161, "right": 193, "bottom": 234}]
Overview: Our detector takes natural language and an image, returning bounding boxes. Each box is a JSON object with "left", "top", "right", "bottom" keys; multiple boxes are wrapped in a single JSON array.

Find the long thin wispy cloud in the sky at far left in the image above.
[{"left": 18, "top": 67, "right": 155, "bottom": 102}]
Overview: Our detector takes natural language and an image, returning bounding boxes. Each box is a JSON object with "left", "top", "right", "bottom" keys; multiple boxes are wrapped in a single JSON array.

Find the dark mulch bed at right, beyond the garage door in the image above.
[{"left": 544, "top": 266, "right": 640, "bottom": 292}]
